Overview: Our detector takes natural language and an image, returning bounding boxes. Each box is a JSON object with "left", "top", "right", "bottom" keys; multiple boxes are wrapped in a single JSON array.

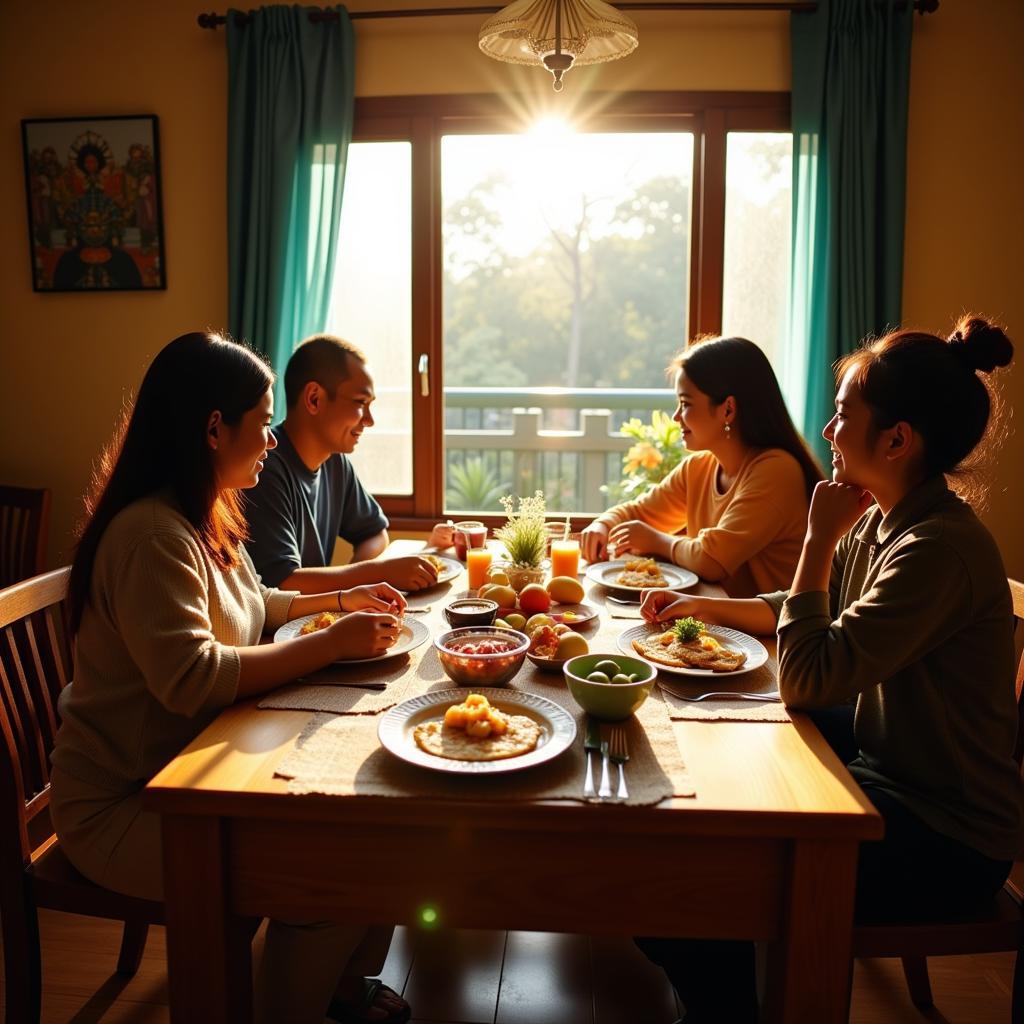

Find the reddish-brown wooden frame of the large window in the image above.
[{"left": 352, "top": 92, "right": 791, "bottom": 530}]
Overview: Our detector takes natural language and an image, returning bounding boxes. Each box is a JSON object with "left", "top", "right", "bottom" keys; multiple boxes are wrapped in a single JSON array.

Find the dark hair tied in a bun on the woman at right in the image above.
[{"left": 836, "top": 314, "right": 1014, "bottom": 500}]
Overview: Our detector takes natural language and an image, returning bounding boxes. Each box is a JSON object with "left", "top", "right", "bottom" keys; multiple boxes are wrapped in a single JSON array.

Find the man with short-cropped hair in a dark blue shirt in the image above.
[{"left": 245, "top": 335, "right": 450, "bottom": 594}]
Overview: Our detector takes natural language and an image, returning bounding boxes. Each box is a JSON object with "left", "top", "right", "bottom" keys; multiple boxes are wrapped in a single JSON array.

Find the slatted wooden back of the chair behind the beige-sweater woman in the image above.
[{"left": 0, "top": 567, "right": 72, "bottom": 870}]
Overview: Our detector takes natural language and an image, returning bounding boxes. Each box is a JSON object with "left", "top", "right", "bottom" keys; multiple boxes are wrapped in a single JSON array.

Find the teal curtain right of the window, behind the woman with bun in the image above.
[{"left": 783, "top": 0, "right": 913, "bottom": 465}]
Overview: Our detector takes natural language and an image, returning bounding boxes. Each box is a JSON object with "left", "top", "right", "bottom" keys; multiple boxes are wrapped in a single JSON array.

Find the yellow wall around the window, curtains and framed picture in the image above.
[{"left": 0, "top": 0, "right": 1024, "bottom": 577}]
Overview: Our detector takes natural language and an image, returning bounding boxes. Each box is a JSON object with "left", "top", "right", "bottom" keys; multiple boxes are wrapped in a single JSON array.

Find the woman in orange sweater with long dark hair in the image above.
[{"left": 583, "top": 338, "right": 821, "bottom": 597}]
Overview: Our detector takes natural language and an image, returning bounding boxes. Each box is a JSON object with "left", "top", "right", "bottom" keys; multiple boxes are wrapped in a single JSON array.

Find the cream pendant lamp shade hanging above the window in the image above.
[{"left": 480, "top": 0, "right": 638, "bottom": 89}]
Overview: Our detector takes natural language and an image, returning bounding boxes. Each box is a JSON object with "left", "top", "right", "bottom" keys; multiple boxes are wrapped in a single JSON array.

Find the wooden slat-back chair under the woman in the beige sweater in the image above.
[{"left": 0, "top": 567, "right": 164, "bottom": 1024}]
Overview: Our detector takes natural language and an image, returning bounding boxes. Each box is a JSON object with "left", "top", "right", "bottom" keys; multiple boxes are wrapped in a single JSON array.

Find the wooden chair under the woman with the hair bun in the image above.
[{"left": 853, "top": 580, "right": 1024, "bottom": 1021}]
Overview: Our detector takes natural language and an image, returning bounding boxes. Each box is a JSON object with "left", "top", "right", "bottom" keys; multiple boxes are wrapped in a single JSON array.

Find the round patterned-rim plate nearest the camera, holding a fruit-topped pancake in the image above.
[{"left": 377, "top": 686, "right": 575, "bottom": 775}]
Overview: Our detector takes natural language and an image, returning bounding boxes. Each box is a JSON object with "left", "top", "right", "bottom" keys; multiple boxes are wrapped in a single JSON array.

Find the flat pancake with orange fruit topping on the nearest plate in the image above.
[{"left": 413, "top": 693, "right": 541, "bottom": 761}]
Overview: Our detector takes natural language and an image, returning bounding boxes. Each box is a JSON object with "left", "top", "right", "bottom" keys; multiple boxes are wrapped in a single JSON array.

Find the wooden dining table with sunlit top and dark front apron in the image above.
[{"left": 144, "top": 541, "right": 883, "bottom": 1024}]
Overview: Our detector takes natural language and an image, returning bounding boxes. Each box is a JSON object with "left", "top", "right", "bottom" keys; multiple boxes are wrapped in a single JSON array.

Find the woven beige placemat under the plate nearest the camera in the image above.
[{"left": 275, "top": 679, "right": 694, "bottom": 806}]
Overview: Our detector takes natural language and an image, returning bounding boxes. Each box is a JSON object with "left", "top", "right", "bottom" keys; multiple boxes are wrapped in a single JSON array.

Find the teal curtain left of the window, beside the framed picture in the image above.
[{"left": 226, "top": 5, "right": 355, "bottom": 411}]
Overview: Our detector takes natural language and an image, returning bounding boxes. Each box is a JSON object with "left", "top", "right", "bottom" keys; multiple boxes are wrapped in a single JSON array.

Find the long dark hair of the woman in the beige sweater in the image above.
[{"left": 68, "top": 332, "right": 273, "bottom": 632}]
